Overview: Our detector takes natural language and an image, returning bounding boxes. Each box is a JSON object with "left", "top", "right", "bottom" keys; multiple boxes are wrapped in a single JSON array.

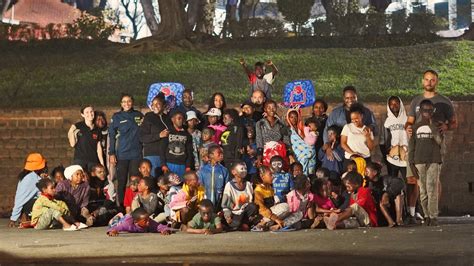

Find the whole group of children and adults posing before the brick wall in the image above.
[{"left": 10, "top": 59, "right": 457, "bottom": 236}]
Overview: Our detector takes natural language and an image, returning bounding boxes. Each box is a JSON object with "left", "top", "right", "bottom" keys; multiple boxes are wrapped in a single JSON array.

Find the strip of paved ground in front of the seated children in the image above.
[{"left": 0, "top": 218, "right": 474, "bottom": 266}]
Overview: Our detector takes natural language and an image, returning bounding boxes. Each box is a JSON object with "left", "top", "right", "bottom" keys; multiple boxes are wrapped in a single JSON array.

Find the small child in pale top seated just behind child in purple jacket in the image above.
[{"left": 132, "top": 176, "right": 158, "bottom": 218}]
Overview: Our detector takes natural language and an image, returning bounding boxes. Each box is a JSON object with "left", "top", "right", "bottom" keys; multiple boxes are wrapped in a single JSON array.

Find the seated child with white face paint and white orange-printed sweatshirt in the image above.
[{"left": 222, "top": 162, "right": 258, "bottom": 231}]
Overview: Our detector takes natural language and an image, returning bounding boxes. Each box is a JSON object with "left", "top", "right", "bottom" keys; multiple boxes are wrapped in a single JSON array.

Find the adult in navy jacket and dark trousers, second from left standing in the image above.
[{"left": 109, "top": 94, "right": 143, "bottom": 205}]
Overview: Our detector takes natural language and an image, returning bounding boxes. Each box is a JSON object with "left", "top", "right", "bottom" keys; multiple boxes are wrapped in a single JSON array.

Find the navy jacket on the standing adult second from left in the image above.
[{"left": 109, "top": 109, "right": 143, "bottom": 160}]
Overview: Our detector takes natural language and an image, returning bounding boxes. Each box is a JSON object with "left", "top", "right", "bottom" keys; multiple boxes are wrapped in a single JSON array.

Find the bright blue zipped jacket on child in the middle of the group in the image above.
[{"left": 197, "top": 163, "right": 229, "bottom": 207}]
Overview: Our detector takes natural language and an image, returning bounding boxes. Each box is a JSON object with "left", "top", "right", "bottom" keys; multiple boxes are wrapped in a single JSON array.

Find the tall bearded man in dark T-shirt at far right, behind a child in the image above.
[{"left": 405, "top": 70, "right": 458, "bottom": 222}]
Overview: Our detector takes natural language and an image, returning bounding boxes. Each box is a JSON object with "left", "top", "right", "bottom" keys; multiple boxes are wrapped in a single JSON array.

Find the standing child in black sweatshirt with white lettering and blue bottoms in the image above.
[{"left": 160, "top": 111, "right": 194, "bottom": 177}]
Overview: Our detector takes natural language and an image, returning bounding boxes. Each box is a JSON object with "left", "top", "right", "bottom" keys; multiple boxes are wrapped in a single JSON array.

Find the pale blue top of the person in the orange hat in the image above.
[{"left": 10, "top": 172, "right": 41, "bottom": 221}]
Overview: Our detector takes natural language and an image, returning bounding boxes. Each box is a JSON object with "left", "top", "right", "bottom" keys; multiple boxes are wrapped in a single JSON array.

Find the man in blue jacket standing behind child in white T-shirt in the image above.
[{"left": 322, "top": 86, "right": 378, "bottom": 161}]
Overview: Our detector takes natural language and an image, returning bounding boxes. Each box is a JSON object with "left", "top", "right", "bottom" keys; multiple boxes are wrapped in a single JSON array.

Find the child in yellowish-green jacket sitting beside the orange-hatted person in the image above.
[{"left": 31, "top": 178, "right": 87, "bottom": 231}]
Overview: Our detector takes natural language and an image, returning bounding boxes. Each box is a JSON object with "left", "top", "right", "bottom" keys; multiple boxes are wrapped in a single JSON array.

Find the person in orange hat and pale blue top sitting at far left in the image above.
[{"left": 8, "top": 153, "right": 48, "bottom": 227}]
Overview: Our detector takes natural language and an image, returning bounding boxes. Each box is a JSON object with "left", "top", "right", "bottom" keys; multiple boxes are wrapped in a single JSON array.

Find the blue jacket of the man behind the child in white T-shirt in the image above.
[{"left": 323, "top": 105, "right": 378, "bottom": 143}]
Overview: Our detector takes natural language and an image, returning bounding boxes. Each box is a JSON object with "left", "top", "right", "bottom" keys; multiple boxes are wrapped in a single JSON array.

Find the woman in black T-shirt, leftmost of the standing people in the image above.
[{"left": 67, "top": 105, "right": 104, "bottom": 172}]
